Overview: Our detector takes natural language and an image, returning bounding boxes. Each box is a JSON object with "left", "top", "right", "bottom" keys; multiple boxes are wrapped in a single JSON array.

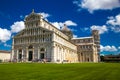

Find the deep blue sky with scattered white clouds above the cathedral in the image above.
[{"left": 0, "top": 0, "right": 120, "bottom": 54}]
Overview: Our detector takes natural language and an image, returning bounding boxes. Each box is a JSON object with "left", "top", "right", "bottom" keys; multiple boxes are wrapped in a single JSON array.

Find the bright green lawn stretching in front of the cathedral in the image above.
[{"left": 0, "top": 63, "right": 120, "bottom": 80}]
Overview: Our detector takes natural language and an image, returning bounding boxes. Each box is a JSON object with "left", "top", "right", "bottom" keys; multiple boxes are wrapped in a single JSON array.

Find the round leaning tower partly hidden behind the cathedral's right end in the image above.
[{"left": 92, "top": 30, "right": 100, "bottom": 61}]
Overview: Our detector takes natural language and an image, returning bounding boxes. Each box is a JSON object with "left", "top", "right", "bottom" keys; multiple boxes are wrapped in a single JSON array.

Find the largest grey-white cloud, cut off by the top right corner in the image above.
[{"left": 73, "top": 0, "right": 120, "bottom": 13}]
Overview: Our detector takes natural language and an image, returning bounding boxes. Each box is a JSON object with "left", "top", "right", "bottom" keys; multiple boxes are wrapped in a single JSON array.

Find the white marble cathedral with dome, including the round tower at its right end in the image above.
[{"left": 11, "top": 10, "right": 100, "bottom": 63}]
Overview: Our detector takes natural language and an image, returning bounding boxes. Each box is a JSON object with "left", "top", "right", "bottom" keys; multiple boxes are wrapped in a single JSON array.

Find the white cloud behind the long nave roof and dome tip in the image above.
[{"left": 51, "top": 20, "right": 77, "bottom": 29}]
